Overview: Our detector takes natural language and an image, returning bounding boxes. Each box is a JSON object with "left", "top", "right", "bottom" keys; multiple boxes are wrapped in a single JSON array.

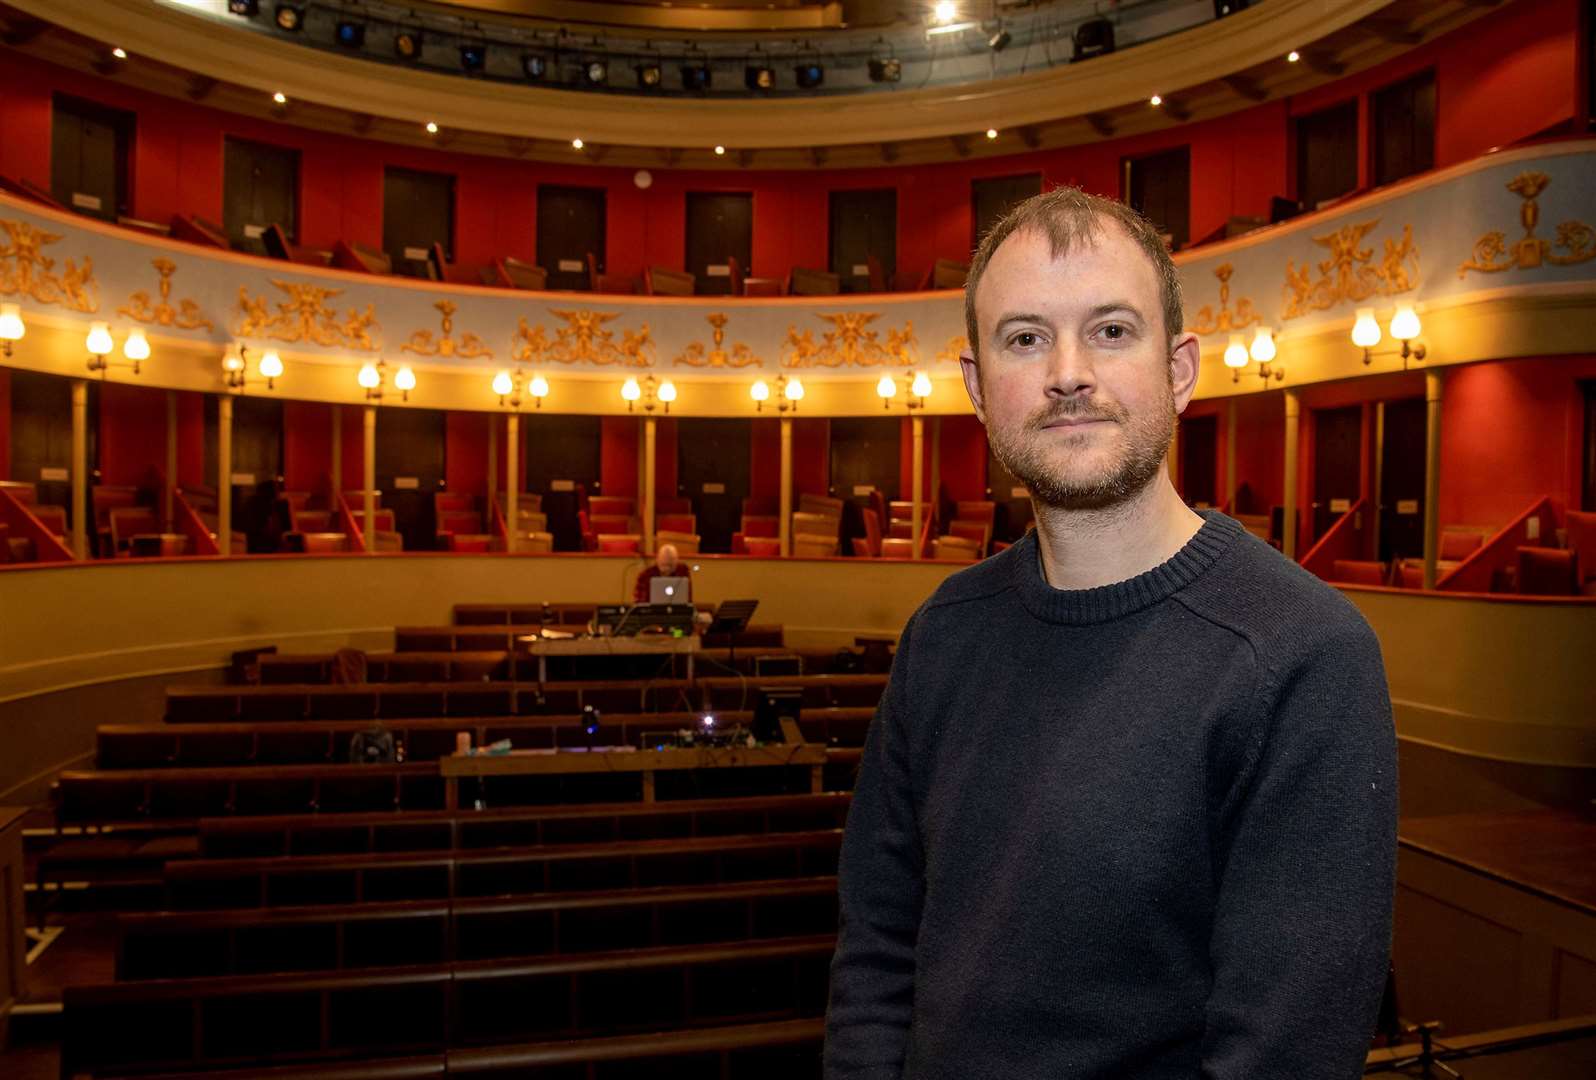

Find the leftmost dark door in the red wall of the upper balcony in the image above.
[{"left": 49, "top": 94, "right": 134, "bottom": 222}]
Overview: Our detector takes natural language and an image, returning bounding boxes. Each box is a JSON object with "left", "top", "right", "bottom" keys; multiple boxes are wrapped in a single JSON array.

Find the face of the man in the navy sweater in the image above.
[{"left": 964, "top": 222, "right": 1197, "bottom": 510}]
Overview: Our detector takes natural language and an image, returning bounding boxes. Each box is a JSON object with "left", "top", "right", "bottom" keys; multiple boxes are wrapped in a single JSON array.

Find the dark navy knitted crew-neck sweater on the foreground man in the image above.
[{"left": 825, "top": 514, "right": 1397, "bottom": 1080}]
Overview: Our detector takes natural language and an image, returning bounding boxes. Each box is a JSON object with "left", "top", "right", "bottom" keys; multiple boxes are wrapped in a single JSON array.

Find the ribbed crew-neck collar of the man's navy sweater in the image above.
[{"left": 1010, "top": 510, "right": 1243, "bottom": 625}]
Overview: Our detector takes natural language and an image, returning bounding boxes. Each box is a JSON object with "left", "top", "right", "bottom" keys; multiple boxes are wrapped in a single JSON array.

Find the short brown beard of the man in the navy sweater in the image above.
[{"left": 986, "top": 379, "right": 1175, "bottom": 510}]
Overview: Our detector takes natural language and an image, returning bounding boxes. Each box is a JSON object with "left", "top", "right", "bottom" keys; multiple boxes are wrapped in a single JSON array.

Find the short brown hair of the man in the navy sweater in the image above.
[{"left": 964, "top": 187, "right": 1186, "bottom": 359}]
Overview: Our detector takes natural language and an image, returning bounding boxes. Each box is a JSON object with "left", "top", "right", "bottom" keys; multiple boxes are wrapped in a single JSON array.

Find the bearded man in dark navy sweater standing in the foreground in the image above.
[{"left": 825, "top": 188, "right": 1397, "bottom": 1080}]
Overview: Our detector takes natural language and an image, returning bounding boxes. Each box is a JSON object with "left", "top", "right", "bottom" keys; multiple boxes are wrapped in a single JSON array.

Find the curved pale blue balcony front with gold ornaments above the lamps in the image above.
[{"left": 0, "top": 139, "right": 1596, "bottom": 415}]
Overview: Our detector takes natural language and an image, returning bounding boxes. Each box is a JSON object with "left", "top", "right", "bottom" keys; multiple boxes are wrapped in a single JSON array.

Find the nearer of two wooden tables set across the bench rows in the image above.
[{"left": 437, "top": 743, "right": 828, "bottom": 810}]
